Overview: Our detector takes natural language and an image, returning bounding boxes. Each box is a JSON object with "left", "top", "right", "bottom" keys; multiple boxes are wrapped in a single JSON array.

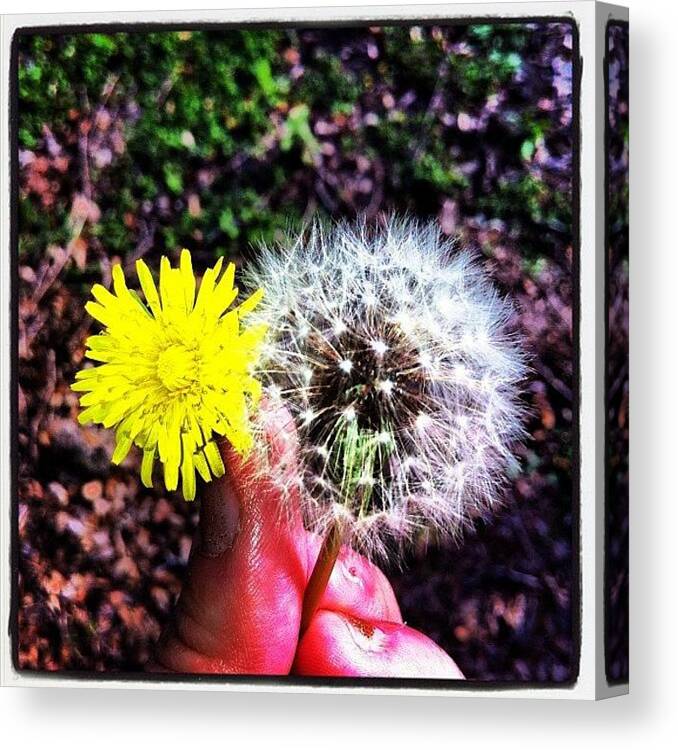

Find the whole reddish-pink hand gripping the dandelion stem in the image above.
[{"left": 149, "top": 410, "right": 463, "bottom": 679}]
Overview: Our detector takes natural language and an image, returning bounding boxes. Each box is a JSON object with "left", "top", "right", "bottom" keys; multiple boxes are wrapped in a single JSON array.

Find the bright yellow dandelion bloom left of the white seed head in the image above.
[{"left": 72, "top": 250, "right": 266, "bottom": 500}]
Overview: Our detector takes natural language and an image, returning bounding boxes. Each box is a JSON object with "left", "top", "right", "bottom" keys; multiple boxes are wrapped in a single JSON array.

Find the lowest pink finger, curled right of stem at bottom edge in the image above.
[{"left": 292, "top": 610, "right": 464, "bottom": 679}]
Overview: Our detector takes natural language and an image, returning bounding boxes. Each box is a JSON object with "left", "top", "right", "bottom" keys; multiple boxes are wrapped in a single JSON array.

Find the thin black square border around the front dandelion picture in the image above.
[{"left": 8, "top": 15, "right": 583, "bottom": 693}]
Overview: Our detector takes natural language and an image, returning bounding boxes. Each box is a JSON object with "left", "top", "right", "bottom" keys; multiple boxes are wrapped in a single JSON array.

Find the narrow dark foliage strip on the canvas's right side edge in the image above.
[{"left": 605, "top": 22, "right": 629, "bottom": 682}]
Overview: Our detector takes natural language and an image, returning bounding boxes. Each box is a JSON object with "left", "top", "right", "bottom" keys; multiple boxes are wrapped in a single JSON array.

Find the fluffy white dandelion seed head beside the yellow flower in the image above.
[{"left": 247, "top": 219, "right": 526, "bottom": 557}]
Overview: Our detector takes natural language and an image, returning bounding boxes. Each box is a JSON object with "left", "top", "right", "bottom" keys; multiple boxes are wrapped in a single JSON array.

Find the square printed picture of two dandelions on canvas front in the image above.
[{"left": 11, "top": 18, "right": 580, "bottom": 687}]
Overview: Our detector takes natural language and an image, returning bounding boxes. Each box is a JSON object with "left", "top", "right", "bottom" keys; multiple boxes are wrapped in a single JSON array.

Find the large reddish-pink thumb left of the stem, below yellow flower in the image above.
[{"left": 157, "top": 410, "right": 307, "bottom": 674}]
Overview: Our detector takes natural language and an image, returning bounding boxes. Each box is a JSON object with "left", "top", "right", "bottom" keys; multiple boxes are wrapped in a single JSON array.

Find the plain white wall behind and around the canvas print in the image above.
[{"left": 0, "top": 0, "right": 678, "bottom": 750}]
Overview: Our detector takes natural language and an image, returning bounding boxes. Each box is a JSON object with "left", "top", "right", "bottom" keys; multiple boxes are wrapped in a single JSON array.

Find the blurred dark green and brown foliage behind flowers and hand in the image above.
[{"left": 18, "top": 22, "right": 577, "bottom": 683}]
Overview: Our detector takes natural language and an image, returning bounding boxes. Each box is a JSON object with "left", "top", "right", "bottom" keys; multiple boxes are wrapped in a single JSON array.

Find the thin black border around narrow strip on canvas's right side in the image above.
[{"left": 603, "top": 19, "right": 630, "bottom": 685}]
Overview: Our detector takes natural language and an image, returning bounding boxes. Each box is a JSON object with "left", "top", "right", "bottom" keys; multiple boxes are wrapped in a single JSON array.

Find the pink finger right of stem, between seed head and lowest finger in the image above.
[{"left": 307, "top": 534, "right": 403, "bottom": 623}]
